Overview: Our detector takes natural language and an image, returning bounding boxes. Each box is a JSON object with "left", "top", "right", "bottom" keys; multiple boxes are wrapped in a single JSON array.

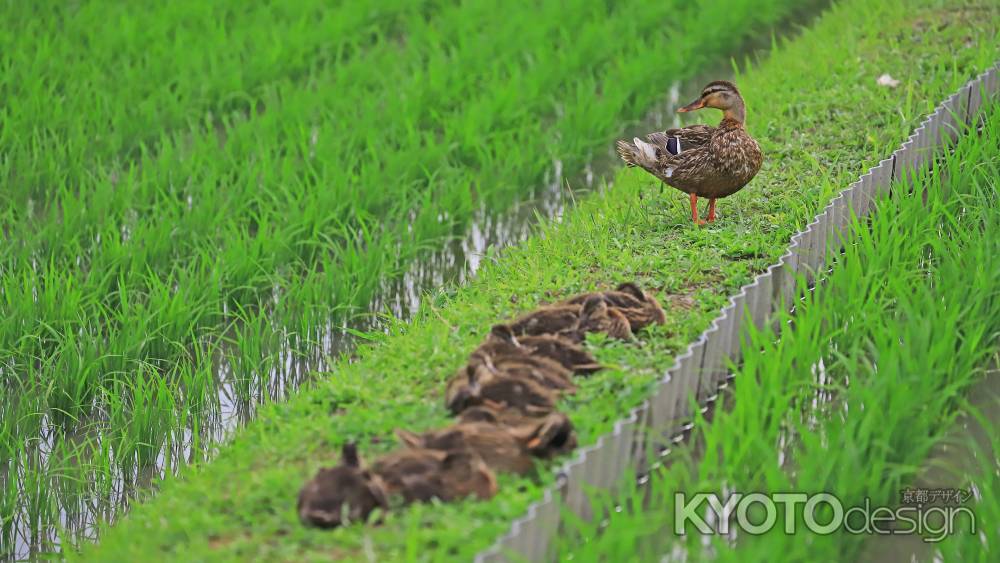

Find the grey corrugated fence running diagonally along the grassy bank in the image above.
[{"left": 476, "top": 63, "right": 1000, "bottom": 563}]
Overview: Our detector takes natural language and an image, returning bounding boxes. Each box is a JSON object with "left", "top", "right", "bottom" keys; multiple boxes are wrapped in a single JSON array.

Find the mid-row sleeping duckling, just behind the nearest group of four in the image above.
[{"left": 445, "top": 364, "right": 559, "bottom": 416}]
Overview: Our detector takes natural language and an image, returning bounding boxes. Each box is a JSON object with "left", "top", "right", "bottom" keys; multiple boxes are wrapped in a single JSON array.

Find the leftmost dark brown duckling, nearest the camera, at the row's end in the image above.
[{"left": 298, "top": 443, "right": 389, "bottom": 528}]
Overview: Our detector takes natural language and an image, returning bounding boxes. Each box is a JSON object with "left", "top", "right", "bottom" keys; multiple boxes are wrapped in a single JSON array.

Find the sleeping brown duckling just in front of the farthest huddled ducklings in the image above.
[{"left": 473, "top": 324, "right": 601, "bottom": 374}]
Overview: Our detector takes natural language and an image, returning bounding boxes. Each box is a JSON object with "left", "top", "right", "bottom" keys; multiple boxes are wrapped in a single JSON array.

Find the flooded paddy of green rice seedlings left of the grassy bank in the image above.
[{"left": 0, "top": 0, "right": 812, "bottom": 554}]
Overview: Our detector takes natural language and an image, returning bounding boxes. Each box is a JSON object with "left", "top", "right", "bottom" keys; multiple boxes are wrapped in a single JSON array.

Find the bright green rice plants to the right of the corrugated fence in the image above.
[{"left": 561, "top": 99, "right": 1000, "bottom": 561}]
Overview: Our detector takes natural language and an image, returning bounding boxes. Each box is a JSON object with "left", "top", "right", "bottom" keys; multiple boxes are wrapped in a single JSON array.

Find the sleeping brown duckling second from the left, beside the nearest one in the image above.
[{"left": 372, "top": 444, "right": 497, "bottom": 503}]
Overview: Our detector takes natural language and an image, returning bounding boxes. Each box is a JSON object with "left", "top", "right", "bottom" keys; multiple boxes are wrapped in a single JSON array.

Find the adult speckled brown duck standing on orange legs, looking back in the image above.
[{"left": 618, "top": 80, "right": 764, "bottom": 225}]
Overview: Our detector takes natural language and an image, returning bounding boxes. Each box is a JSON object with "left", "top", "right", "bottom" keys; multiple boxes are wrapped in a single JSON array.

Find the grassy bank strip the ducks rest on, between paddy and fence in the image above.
[{"left": 72, "top": 0, "right": 1000, "bottom": 561}]
